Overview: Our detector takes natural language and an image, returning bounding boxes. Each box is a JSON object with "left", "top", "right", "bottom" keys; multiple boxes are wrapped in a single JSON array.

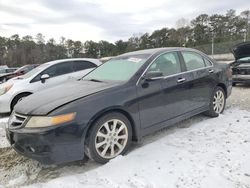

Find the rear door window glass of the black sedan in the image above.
[{"left": 182, "top": 52, "right": 206, "bottom": 71}]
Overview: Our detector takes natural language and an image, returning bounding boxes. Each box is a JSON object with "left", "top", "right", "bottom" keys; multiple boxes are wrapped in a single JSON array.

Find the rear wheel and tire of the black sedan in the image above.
[{"left": 205, "top": 86, "right": 226, "bottom": 117}]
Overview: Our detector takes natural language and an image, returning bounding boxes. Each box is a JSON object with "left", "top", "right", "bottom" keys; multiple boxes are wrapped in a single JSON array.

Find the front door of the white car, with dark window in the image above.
[{"left": 31, "top": 62, "right": 74, "bottom": 91}]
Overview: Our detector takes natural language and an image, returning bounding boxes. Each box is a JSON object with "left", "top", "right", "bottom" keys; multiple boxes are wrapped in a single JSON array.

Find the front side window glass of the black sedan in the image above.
[{"left": 148, "top": 52, "right": 181, "bottom": 76}]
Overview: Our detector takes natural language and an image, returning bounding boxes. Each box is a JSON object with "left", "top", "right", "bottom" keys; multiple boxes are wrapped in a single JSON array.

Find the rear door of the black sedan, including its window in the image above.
[{"left": 181, "top": 51, "right": 214, "bottom": 111}]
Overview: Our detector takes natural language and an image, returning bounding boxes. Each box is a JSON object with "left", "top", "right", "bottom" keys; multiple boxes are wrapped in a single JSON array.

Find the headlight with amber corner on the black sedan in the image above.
[{"left": 25, "top": 112, "right": 76, "bottom": 128}]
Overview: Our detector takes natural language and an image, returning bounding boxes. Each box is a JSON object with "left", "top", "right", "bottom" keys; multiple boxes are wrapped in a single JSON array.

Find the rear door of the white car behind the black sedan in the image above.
[{"left": 71, "top": 61, "right": 97, "bottom": 79}]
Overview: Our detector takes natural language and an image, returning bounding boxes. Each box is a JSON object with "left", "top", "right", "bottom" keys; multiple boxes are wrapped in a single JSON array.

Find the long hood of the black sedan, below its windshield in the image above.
[{"left": 15, "top": 80, "right": 118, "bottom": 115}]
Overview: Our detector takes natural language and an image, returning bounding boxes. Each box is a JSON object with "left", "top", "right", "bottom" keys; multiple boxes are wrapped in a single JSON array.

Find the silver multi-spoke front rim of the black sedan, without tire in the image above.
[{"left": 95, "top": 119, "right": 128, "bottom": 159}]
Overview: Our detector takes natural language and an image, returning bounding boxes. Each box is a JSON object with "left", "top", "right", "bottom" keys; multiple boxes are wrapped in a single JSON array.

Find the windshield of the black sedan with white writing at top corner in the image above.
[{"left": 83, "top": 54, "right": 150, "bottom": 81}]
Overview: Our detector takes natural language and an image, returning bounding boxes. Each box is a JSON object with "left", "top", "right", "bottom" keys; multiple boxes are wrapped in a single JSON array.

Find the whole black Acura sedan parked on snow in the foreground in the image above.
[{"left": 6, "top": 48, "right": 232, "bottom": 164}]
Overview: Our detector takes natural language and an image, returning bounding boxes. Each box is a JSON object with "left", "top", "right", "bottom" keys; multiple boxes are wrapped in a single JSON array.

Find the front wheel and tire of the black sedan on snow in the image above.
[{"left": 85, "top": 112, "right": 132, "bottom": 164}]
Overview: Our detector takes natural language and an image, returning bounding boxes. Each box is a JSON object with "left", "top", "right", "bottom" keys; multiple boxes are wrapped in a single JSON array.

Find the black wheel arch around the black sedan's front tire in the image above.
[{"left": 86, "top": 107, "right": 139, "bottom": 141}]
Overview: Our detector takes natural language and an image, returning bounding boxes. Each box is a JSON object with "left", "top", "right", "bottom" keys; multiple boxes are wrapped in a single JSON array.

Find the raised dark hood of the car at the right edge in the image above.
[{"left": 232, "top": 42, "right": 250, "bottom": 60}]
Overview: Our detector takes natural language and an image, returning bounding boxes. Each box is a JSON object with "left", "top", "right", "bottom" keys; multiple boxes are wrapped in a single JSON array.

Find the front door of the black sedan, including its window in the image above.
[{"left": 137, "top": 52, "right": 188, "bottom": 128}]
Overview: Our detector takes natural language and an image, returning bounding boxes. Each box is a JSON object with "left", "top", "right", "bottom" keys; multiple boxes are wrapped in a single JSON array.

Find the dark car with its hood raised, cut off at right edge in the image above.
[{"left": 231, "top": 42, "right": 250, "bottom": 85}]
